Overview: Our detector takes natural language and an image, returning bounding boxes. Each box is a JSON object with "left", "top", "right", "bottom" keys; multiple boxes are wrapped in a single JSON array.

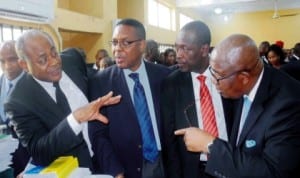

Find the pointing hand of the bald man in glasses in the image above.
[{"left": 174, "top": 127, "right": 216, "bottom": 153}]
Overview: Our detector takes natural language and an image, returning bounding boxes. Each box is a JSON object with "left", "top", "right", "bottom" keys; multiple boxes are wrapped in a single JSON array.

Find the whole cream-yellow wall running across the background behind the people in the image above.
[{"left": 0, "top": 0, "right": 300, "bottom": 63}]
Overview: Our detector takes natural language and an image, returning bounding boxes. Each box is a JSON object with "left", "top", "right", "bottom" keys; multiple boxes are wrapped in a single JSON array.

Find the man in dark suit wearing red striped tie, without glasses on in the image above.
[{"left": 161, "top": 21, "right": 232, "bottom": 178}]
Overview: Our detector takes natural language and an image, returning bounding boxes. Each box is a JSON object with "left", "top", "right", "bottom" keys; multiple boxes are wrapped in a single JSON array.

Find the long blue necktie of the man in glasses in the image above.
[{"left": 129, "top": 73, "right": 158, "bottom": 163}]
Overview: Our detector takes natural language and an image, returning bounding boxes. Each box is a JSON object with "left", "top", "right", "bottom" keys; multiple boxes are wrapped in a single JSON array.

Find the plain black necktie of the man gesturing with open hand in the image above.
[{"left": 53, "top": 82, "right": 71, "bottom": 114}]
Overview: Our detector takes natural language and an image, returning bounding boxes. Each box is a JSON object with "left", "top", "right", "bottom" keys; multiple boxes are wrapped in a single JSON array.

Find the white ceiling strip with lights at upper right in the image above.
[{"left": 175, "top": 0, "right": 300, "bottom": 15}]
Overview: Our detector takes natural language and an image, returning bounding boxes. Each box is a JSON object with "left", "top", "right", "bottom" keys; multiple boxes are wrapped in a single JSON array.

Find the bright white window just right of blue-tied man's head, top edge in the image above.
[{"left": 148, "top": 0, "right": 176, "bottom": 31}]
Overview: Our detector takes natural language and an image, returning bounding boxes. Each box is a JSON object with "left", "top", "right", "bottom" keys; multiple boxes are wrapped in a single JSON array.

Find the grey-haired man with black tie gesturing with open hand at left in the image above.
[{"left": 5, "top": 30, "right": 120, "bottom": 169}]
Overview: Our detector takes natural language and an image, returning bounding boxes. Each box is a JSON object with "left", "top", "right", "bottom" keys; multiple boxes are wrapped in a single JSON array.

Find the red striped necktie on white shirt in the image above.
[{"left": 197, "top": 75, "right": 218, "bottom": 137}]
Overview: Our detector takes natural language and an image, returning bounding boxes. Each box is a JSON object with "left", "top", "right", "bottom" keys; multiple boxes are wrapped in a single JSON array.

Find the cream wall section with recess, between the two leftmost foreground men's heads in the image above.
[{"left": 51, "top": 0, "right": 117, "bottom": 63}]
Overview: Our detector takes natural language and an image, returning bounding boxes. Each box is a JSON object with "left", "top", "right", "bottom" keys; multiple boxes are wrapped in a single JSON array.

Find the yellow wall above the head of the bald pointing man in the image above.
[{"left": 206, "top": 9, "right": 300, "bottom": 48}]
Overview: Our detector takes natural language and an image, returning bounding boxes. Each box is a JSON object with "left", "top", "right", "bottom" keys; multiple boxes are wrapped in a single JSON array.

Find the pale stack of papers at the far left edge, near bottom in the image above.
[{"left": 0, "top": 134, "right": 19, "bottom": 172}]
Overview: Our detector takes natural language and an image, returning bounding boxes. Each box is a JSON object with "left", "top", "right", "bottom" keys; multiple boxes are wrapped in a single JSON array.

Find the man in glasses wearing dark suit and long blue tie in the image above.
[{"left": 89, "top": 19, "right": 169, "bottom": 178}]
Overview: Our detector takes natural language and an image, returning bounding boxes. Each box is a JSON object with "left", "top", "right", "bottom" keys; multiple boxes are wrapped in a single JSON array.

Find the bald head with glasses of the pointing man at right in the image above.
[{"left": 210, "top": 34, "right": 263, "bottom": 98}]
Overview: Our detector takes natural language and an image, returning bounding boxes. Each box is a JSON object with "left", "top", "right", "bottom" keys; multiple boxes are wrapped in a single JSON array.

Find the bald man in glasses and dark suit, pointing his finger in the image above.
[{"left": 176, "top": 34, "right": 300, "bottom": 178}]
